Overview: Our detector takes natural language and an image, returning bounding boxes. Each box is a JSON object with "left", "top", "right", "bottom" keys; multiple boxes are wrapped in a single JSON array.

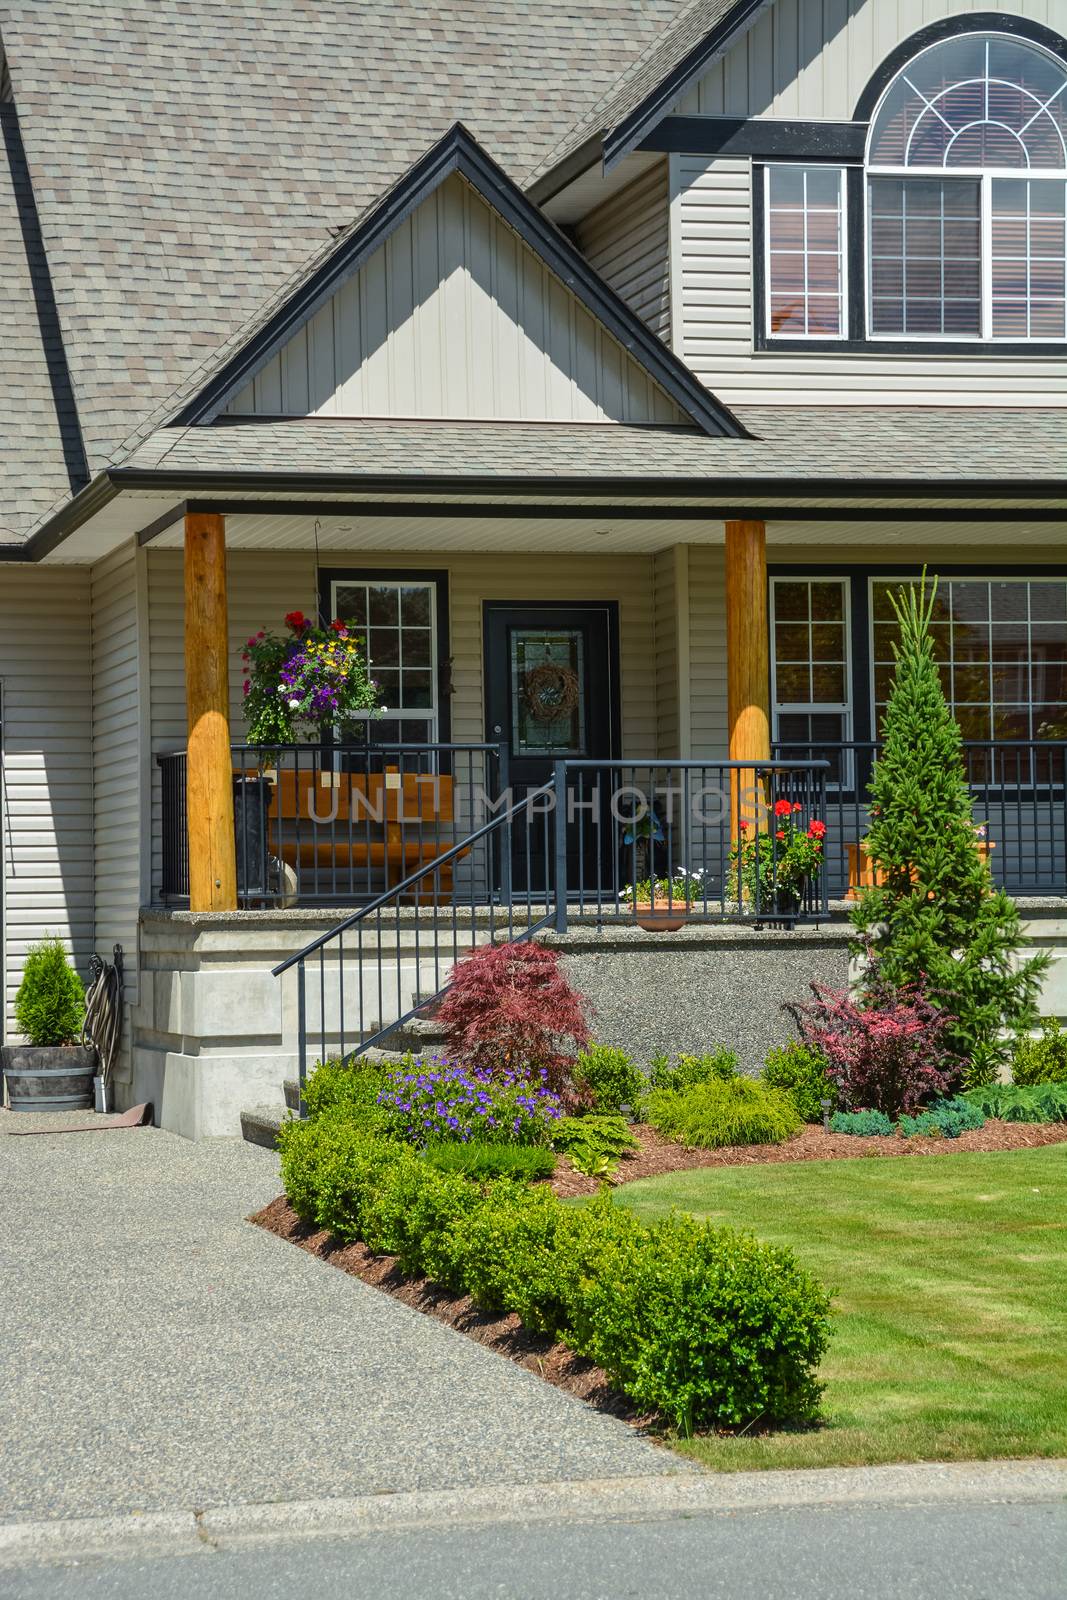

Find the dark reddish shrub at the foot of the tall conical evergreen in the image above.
[{"left": 785, "top": 962, "right": 960, "bottom": 1117}]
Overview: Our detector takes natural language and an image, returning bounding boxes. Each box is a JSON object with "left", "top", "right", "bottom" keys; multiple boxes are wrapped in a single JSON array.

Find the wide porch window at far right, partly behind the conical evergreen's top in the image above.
[{"left": 870, "top": 578, "right": 1067, "bottom": 742}]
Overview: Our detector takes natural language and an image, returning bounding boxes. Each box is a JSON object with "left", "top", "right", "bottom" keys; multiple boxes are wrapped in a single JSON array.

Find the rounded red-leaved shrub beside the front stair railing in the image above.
[{"left": 437, "top": 944, "right": 589, "bottom": 1093}]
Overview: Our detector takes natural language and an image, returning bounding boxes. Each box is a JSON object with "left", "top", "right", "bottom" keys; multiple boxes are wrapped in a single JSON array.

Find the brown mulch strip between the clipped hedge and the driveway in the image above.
[{"left": 248, "top": 1186, "right": 657, "bottom": 1437}]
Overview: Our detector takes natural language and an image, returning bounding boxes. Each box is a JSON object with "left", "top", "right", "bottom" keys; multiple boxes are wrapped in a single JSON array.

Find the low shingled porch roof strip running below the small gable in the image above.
[{"left": 123, "top": 406, "right": 1067, "bottom": 494}]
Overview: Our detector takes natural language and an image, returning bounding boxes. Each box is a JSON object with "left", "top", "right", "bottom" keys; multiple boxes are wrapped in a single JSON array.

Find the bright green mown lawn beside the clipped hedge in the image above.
[{"left": 616, "top": 1146, "right": 1067, "bottom": 1470}]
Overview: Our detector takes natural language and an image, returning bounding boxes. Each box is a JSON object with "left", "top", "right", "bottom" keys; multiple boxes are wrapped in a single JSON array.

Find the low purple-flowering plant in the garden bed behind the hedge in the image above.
[{"left": 378, "top": 1056, "right": 563, "bottom": 1144}]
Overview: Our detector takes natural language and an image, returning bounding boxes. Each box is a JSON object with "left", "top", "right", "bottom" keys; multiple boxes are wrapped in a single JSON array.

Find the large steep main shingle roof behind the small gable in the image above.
[{"left": 0, "top": 0, "right": 678, "bottom": 541}]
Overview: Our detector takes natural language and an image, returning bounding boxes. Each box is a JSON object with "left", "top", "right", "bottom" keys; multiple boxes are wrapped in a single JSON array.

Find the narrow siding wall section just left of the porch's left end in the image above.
[{"left": 90, "top": 546, "right": 144, "bottom": 1005}]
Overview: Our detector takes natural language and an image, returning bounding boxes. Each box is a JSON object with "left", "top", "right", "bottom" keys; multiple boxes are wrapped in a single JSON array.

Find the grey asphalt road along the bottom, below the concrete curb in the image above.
[{"left": 8, "top": 1502, "right": 1067, "bottom": 1600}]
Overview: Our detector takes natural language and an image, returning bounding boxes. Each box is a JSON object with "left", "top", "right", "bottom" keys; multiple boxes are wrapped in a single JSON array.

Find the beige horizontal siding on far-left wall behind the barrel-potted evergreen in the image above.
[{"left": 0, "top": 565, "right": 93, "bottom": 1037}]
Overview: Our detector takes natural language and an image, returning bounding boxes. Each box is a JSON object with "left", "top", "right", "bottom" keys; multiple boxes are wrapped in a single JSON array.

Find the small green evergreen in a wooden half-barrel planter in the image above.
[{"left": 0, "top": 938, "right": 96, "bottom": 1110}]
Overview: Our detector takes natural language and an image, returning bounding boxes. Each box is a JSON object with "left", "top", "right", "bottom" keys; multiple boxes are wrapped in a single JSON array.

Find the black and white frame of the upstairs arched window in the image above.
[{"left": 750, "top": 23, "right": 1067, "bottom": 360}]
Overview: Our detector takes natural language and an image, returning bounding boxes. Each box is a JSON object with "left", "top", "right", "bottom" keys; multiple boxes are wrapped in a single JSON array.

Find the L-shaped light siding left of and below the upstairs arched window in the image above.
[{"left": 670, "top": 155, "right": 1067, "bottom": 405}]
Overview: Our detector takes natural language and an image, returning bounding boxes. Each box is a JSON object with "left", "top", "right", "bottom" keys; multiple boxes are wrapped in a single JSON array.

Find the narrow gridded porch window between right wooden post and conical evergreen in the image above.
[{"left": 771, "top": 578, "right": 853, "bottom": 782}]
